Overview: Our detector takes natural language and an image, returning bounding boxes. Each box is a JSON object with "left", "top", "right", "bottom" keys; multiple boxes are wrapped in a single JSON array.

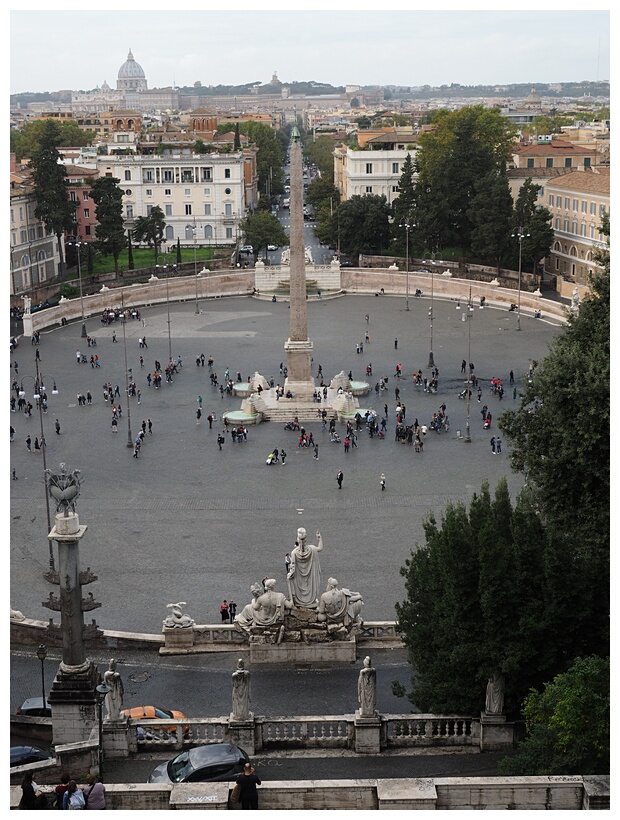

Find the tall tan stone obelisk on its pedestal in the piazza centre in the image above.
[{"left": 284, "top": 126, "right": 315, "bottom": 399}]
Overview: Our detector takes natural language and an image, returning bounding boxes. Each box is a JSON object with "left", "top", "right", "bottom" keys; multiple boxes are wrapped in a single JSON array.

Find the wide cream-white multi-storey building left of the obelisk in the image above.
[{"left": 97, "top": 148, "right": 258, "bottom": 245}]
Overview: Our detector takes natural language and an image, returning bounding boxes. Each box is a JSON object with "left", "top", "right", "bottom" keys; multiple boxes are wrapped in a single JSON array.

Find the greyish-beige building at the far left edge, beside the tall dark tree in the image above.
[{"left": 9, "top": 154, "right": 60, "bottom": 296}]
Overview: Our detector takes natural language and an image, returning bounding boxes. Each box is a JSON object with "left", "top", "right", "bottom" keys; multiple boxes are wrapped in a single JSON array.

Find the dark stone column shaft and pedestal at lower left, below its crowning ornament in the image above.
[{"left": 43, "top": 512, "right": 99, "bottom": 745}]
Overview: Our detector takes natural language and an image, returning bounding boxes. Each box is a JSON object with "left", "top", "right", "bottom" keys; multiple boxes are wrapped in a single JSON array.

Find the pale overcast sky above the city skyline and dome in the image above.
[{"left": 9, "top": 0, "right": 610, "bottom": 93}]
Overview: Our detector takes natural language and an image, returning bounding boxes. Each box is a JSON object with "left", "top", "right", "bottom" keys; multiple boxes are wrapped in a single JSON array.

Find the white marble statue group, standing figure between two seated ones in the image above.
[{"left": 234, "top": 527, "right": 364, "bottom": 644}]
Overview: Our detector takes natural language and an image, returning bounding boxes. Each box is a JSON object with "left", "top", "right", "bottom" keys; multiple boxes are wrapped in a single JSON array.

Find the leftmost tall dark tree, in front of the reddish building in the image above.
[{"left": 30, "top": 120, "right": 77, "bottom": 268}]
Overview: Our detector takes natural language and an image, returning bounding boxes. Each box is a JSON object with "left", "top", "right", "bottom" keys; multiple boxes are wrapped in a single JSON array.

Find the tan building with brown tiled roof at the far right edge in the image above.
[{"left": 544, "top": 168, "right": 610, "bottom": 284}]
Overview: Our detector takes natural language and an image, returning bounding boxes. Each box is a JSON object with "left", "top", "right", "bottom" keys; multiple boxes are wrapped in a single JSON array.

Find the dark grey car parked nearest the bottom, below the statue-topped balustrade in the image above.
[{"left": 148, "top": 743, "right": 250, "bottom": 783}]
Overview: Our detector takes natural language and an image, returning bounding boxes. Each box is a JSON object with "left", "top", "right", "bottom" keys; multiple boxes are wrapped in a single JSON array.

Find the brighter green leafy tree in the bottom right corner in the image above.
[{"left": 499, "top": 656, "right": 610, "bottom": 776}]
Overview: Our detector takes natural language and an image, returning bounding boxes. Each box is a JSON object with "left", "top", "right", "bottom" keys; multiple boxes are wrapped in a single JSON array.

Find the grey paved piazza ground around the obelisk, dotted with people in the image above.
[{"left": 10, "top": 296, "right": 558, "bottom": 633}]
